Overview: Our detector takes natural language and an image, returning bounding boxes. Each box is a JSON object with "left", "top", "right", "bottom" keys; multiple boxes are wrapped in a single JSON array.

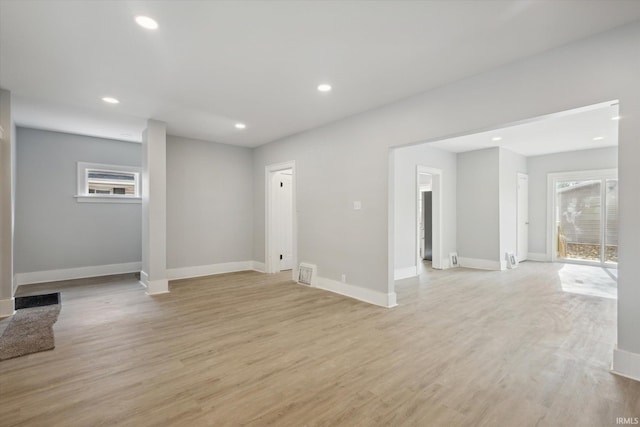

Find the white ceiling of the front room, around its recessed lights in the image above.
[{"left": 0, "top": 0, "right": 640, "bottom": 147}]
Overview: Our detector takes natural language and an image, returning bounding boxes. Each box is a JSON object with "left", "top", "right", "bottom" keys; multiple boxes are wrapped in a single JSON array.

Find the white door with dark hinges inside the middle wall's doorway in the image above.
[{"left": 273, "top": 171, "right": 293, "bottom": 271}]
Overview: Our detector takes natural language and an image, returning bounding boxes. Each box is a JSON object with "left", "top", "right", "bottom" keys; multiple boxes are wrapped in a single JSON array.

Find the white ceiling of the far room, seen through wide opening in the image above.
[{"left": 429, "top": 102, "right": 619, "bottom": 157}]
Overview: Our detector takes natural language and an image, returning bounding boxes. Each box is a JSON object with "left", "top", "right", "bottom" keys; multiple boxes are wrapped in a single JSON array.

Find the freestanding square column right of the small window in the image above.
[{"left": 140, "top": 120, "right": 169, "bottom": 295}]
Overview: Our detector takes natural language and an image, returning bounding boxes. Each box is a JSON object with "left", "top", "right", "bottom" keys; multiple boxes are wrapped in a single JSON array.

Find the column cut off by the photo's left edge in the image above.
[{"left": 0, "top": 89, "right": 15, "bottom": 318}]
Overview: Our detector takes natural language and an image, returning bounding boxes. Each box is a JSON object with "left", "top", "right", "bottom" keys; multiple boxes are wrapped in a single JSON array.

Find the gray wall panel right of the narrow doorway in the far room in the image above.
[{"left": 457, "top": 147, "right": 500, "bottom": 262}]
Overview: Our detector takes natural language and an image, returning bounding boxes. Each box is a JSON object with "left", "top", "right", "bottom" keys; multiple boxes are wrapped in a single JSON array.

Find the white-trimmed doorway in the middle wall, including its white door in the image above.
[{"left": 265, "top": 162, "right": 297, "bottom": 278}]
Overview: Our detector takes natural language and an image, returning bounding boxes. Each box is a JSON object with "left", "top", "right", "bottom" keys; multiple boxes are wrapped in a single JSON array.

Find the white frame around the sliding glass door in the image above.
[{"left": 547, "top": 168, "right": 618, "bottom": 267}]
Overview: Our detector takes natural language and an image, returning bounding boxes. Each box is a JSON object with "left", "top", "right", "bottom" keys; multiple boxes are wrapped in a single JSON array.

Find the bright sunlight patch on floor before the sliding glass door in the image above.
[{"left": 558, "top": 264, "right": 618, "bottom": 299}]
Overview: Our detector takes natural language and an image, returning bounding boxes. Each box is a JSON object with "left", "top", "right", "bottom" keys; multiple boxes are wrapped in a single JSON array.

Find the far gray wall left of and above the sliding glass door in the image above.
[{"left": 527, "top": 147, "right": 620, "bottom": 254}]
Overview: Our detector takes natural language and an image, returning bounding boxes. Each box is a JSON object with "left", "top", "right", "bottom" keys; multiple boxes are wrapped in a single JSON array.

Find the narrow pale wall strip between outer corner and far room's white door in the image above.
[{"left": 499, "top": 148, "right": 527, "bottom": 264}]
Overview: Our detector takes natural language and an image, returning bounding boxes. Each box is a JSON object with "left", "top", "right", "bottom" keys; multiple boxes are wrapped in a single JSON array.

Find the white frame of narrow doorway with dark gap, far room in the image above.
[{"left": 415, "top": 165, "right": 448, "bottom": 275}]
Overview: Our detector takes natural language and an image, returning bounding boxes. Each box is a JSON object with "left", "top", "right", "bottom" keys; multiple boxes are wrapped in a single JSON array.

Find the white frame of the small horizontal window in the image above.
[{"left": 75, "top": 162, "right": 142, "bottom": 203}]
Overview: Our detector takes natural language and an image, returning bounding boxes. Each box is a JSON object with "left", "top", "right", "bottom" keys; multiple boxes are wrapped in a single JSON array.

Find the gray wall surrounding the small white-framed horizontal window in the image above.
[{"left": 14, "top": 127, "right": 141, "bottom": 273}]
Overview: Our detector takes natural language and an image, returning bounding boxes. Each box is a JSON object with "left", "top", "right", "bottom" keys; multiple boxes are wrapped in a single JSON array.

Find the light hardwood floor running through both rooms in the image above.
[{"left": 0, "top": 262, "right": 640, "bottom": 427}]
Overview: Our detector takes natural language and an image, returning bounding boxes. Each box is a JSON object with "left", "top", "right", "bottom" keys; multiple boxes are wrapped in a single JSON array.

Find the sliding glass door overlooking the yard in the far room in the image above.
[{"left": 551, "top": 170, "right": 618, "bottom": 265}]
